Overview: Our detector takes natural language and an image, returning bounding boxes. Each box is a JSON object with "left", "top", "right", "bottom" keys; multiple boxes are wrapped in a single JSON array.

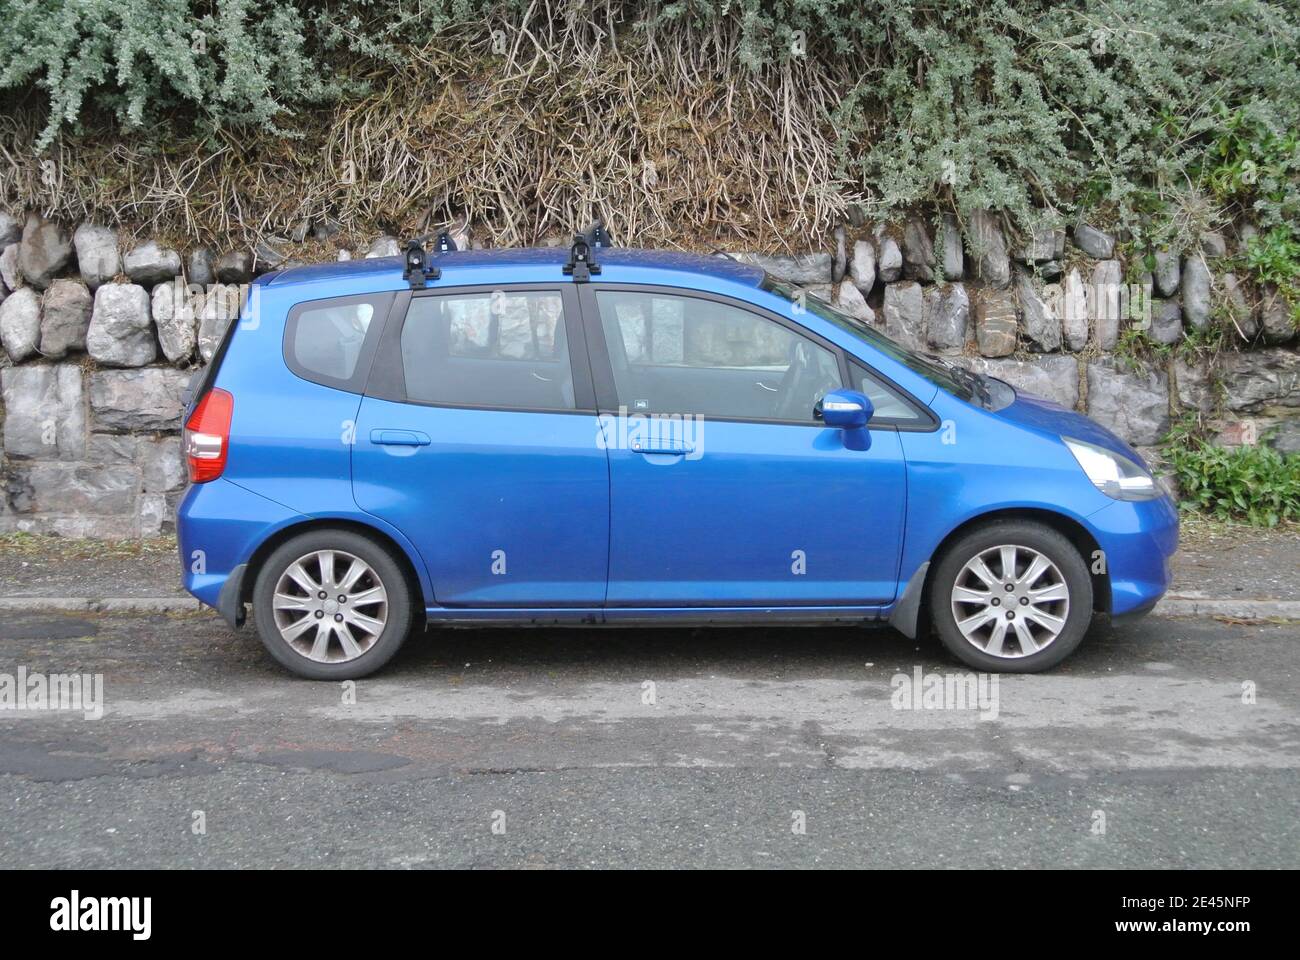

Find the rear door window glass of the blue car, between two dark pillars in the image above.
[{"left": 402, "top": 290, "right": 575, "bottom": 410}]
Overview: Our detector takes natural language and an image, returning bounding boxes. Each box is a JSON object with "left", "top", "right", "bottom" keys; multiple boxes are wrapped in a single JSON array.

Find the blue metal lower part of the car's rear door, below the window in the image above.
[{"left": 352, "top": 397, "right": 610, "bottom": 598}]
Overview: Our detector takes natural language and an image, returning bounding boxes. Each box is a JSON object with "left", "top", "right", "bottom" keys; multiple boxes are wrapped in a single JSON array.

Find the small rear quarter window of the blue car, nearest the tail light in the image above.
[{"left": 285, "top": 294, "right": 393, "bottom": 393}]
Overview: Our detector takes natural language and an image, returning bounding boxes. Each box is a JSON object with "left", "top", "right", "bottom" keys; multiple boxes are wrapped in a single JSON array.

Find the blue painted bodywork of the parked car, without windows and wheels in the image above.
[{"left": 178, "top": 243, "right": 1178, "bottom": 623}]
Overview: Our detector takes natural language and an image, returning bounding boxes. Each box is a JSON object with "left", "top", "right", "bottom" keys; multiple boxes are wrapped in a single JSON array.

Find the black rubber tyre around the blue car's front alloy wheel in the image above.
[{"left": 928, "top": 520, "right": 1092, "bottom": 674}]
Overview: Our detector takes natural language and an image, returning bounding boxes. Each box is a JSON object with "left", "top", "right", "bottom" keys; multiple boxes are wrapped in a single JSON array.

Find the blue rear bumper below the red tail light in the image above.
[{"left": 176, "top": 479, "right": 300, "bottom": 626}]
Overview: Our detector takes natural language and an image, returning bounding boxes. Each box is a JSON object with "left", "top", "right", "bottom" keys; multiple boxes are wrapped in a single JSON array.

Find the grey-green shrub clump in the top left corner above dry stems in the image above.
[{"left": 0, "top": 0, "right": 361, "bottom": 147}]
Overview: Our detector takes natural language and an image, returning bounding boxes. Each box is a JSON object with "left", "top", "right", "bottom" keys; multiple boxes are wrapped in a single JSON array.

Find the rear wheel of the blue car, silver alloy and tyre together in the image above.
[{"left": 252, "top": 529, "right": 413, "bottom": 680}]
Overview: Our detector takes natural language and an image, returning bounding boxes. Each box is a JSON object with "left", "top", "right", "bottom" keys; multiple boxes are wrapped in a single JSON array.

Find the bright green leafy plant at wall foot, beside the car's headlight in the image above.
[{"left": 1166, "top": 436, "right": 1300, "bottom": 527}]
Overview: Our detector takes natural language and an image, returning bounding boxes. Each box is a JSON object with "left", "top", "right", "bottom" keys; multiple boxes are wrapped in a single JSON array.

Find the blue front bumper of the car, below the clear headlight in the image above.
[{"left": 1088, "top": 497, "right": 1178, "bottom": 617}]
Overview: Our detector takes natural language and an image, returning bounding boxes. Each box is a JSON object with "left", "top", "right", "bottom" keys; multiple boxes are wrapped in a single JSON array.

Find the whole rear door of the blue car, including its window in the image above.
[{"left": 352, "top": 284, "right": 610, "bottom": 607}]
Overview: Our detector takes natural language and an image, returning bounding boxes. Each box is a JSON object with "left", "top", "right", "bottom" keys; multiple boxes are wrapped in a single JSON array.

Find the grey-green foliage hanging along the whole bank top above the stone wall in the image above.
[{"left": 0, "top": 0, "right": 1300, "bottom": 243}]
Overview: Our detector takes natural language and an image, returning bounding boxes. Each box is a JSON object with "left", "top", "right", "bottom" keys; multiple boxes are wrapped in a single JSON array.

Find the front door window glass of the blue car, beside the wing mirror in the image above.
[{"left": 595, "top": 283, "right": 842, "bottom": 423}]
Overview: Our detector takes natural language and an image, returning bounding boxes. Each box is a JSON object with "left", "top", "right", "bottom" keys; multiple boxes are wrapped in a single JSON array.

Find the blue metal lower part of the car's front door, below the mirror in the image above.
[{"left": 607, "top": 420, "right": 907, "bottom": 606}]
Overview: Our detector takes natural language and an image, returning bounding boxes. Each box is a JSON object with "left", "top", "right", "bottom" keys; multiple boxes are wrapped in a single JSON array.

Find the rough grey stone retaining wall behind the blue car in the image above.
[{"left": 0, "top": 211, "right": 1300, "bottom": 537}]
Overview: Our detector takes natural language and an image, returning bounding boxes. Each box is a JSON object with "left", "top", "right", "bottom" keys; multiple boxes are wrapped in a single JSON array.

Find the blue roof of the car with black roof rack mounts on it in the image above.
[{"left": 264, "top": 247, "right": 763, "bottom": 286}]
